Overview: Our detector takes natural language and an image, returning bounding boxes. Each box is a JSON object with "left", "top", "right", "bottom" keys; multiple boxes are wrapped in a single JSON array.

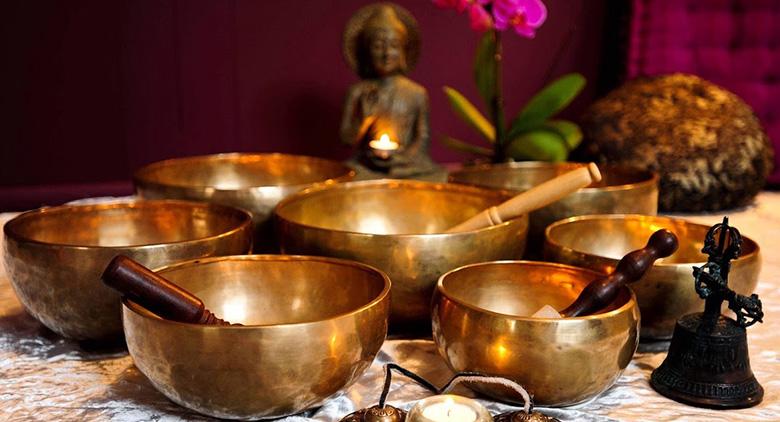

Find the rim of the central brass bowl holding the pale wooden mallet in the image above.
[{"left": 273, "top": 179, "right": 528, "bottom": 237}]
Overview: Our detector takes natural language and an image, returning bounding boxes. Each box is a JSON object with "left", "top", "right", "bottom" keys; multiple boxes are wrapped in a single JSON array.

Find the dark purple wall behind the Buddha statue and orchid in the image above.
[{"left": 0, "top": 0, "right": 617, "bottom": 210}]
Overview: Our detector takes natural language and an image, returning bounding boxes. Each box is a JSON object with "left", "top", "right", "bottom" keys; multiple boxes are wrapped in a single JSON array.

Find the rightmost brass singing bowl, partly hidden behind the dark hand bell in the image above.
[{"left": 544, "top": 215, "right": 761, "bottom": 340}]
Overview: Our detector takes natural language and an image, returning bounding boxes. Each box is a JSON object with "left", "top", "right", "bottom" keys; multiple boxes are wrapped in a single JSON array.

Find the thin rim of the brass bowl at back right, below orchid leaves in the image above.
[{"left": 447, "top": 161, "right": 660, "bottom": 193}]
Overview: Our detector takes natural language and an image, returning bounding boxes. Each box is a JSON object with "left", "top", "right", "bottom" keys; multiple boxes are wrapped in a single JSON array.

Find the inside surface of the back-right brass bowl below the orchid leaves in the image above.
[{"left": 450, "top": 162, "right": 653, "bottom": 191}]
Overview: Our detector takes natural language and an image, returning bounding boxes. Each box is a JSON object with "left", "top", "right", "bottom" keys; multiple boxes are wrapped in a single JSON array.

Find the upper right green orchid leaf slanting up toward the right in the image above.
[{"left": 507, "top": 73, "right": 585, "bottom": 139}]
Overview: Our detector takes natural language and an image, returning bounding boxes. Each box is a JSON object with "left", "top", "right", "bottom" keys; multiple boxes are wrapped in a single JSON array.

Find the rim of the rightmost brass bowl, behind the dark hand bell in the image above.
[{"left": 544, "top": 214, "right": 761, "bottom": 267}]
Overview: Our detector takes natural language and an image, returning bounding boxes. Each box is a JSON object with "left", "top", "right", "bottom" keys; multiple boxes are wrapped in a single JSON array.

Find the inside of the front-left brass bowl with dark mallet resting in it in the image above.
[{"left": 145, "top": 258, "right": 389, "bottom": 325}]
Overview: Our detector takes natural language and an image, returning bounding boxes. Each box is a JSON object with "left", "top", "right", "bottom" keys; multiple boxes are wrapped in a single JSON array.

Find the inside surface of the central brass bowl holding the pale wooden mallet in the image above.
[{"left": 276, "top": 183, "right": 507, "bottom": 234}]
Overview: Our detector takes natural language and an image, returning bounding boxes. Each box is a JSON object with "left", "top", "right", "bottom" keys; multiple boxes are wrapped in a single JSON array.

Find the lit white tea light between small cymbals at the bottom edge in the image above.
[{"left": 406, "top": 394, "right": 493, "bottom": 422}]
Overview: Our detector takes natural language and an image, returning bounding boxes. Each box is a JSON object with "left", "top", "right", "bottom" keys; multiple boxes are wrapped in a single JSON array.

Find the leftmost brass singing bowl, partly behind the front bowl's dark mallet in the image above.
[{"left": 4, "top": 201, "right": 252, "bottom": 340}]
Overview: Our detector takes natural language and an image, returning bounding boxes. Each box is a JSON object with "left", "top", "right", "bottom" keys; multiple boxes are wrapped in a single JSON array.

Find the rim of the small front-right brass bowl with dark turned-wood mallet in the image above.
[{"left": 436, "top": 260, "right": 639, "bottom": 324}]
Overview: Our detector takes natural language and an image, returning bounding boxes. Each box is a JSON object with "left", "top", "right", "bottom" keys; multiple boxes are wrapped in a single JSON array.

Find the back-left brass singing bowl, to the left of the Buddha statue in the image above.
[{"left": 133, "top": 153, "right": 355, "bottom": 252}]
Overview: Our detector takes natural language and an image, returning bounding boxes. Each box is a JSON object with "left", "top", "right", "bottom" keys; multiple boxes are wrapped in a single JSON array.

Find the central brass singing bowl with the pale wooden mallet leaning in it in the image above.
[{"left": 276, "top": 180, "right": 528, "bottom": 330}]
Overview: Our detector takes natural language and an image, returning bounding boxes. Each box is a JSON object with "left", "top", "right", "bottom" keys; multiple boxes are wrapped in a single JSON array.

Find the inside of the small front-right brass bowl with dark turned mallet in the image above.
[{"left": 441, "top": 262, "right": 631, "bottom": 317}]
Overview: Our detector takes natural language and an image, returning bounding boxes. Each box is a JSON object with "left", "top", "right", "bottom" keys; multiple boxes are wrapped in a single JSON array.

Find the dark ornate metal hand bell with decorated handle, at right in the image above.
[{"left": 650, "top": 217, "right": 764, "bottom": 409}]
